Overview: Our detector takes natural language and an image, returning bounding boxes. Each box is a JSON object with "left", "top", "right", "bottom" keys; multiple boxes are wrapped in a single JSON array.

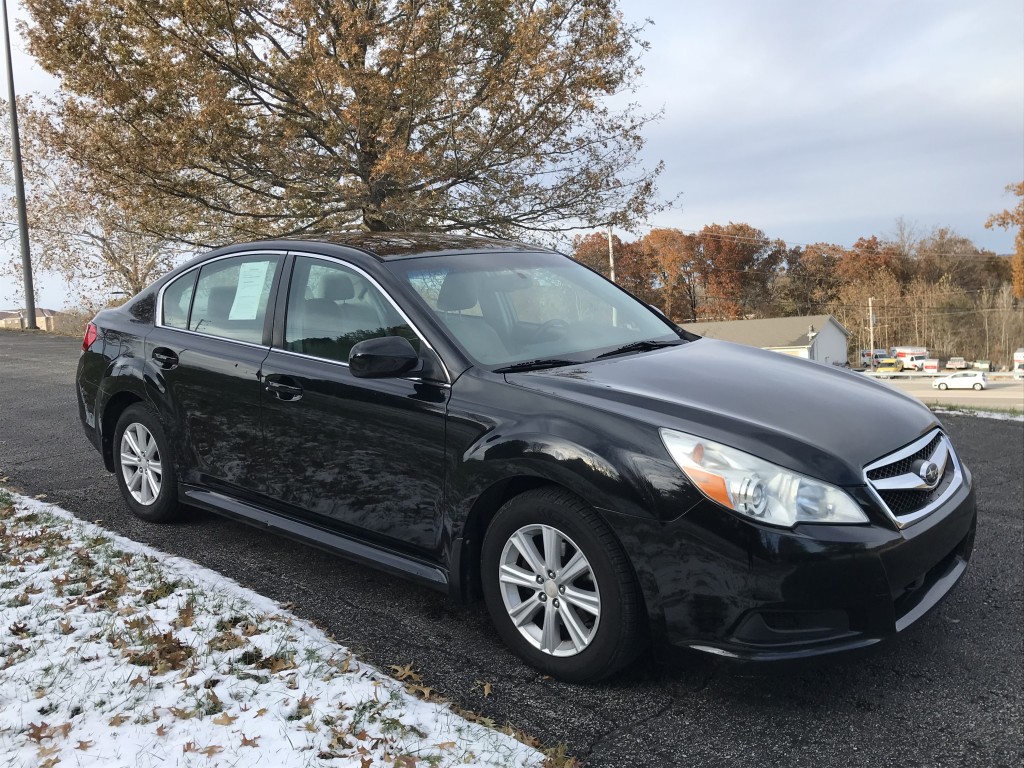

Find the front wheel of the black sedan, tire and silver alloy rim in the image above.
[{"left": 480, "top": 487, "right": 643, "bottom": 682}]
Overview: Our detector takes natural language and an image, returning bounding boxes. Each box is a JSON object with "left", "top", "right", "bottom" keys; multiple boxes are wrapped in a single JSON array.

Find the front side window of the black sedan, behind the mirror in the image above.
[{"left": 285, "top": 256, "right": 420, "bottom": 362}]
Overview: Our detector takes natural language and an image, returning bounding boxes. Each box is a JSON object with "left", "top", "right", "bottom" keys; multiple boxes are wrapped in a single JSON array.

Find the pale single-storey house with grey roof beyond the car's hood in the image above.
[{"left": 683, "top": 314, "right": 850, "bottom": 366}]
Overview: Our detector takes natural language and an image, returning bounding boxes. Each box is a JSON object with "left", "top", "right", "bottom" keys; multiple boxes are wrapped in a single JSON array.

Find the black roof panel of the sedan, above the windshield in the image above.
[{"left": 279, "top": 232, "right": 556, "bottom": 261}]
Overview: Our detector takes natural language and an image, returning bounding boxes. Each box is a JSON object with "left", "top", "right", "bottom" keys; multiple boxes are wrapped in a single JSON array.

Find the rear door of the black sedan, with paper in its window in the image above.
[{"left": 145, "top": 252, "right": 284, "bottom": 498}]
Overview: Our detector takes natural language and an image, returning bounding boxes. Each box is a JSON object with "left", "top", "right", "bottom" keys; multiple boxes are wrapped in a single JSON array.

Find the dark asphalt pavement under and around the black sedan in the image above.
[{"left": 0, "top": 331, "right": 1024, "bottom": 768}]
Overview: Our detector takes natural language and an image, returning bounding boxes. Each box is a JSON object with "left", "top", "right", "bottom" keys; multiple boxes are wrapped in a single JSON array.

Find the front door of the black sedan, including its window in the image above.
[{"left": 263, "top": 256, "right": 449, "bottom": 557}]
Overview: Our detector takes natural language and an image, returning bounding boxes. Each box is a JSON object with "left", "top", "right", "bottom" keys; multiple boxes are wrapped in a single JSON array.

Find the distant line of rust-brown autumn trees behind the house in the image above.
[{"left": 572, "top": 211, "right": 1024, "bottom": 365}]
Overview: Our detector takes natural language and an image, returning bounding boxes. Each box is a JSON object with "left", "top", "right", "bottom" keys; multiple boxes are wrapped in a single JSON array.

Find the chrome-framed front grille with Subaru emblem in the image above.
[{"left": 864, "top": 429, "right": 964, "bottom": 527}]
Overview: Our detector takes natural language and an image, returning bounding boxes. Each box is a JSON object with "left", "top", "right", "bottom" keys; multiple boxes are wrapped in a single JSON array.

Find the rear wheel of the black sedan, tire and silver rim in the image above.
[{"left": 114, "top": 402, "right": 178, "bottom": 522}]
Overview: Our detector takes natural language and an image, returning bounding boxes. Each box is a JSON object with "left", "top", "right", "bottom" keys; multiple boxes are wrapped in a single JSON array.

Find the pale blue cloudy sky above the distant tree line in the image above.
[{"left": 0, "top": 0, "right": 1024, "bottom": 308}]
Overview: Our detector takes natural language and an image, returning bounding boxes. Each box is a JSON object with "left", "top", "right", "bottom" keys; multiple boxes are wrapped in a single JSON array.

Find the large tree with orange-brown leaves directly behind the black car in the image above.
[{"left": 25, "top": 0, "right": 662, "bottom": 245}]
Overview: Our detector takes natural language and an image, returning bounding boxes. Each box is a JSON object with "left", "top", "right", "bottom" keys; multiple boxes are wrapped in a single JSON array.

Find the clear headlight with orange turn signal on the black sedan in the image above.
[{"left": 660, "top": 429, "right": 867, "bottom": 528}]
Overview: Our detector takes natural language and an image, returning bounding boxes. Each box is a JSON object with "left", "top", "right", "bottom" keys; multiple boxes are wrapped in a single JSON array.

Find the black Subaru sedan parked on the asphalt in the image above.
[{"left": 78, "top": 233, "right": 976, "bottom": 680}]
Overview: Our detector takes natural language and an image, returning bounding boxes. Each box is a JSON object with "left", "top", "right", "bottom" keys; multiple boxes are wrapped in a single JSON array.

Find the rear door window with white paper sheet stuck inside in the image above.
[{"left": 188, "top": 255, "right": 278, "bottom": 344}]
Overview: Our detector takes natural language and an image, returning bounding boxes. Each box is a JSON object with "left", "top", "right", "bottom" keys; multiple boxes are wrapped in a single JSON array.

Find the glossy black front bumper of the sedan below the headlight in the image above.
[{"left": 610, "top": 472, "right": 977, "bottom": 662}]
